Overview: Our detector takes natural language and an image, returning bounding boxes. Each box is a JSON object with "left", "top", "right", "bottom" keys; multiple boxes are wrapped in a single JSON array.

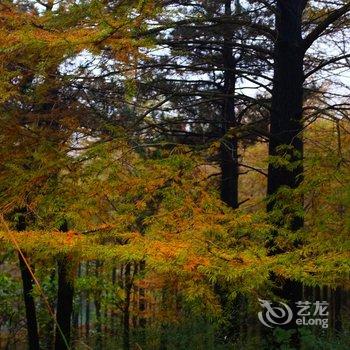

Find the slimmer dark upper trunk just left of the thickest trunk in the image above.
[{"left": 220, "top": 0, "right": 238, "bottom": 208}]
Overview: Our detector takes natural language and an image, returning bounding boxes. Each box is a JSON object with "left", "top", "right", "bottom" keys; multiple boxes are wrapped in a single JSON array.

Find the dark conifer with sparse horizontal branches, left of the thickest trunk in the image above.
[{"left": 124, "top": 1, "right": 272, "bottom": 208}]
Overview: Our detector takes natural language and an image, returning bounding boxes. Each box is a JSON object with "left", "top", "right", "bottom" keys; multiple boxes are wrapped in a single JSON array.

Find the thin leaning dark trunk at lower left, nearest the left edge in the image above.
[{"left": 16, "top": 215, "right": 40, "bottom": 350}]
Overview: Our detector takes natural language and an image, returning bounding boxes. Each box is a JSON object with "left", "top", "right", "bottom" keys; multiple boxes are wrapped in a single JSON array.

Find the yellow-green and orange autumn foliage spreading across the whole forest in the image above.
[{"left": 0, "top": 0, "right": 350, "bottom": 349}]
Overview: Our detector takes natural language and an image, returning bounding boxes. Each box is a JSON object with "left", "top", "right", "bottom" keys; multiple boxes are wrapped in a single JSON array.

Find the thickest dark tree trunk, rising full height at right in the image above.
[{"left": 267, "top": 0, "right": 307, "bottom": 348}]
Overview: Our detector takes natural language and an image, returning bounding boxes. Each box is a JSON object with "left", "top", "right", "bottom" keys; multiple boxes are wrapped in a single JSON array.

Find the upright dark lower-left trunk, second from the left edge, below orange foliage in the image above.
[{"left": 55, "top": 223, "right": 74, "bottom": 350}]
